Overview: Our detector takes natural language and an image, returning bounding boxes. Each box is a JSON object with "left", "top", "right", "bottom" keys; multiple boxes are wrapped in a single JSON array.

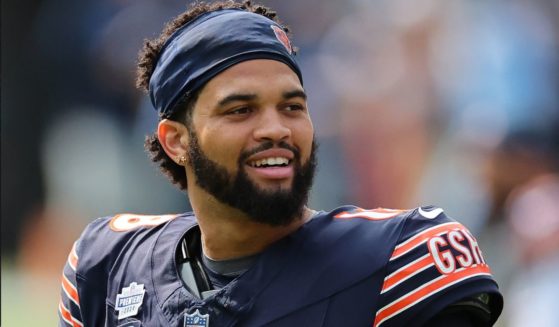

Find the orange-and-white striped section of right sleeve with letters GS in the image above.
[{"left": 373, "top": 218, "right": 492, "bottom": 327}]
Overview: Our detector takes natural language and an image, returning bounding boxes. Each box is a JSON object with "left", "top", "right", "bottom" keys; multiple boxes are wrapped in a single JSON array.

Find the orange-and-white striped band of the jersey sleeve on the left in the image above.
[{"left": 58, "top": 242, "right": 83, "bottom": 327}]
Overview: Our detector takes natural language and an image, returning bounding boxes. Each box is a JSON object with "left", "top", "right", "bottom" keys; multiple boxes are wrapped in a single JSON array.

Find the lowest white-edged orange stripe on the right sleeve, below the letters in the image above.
[{"left": 373, "top": 265, "right": 491, "bottom": 327}]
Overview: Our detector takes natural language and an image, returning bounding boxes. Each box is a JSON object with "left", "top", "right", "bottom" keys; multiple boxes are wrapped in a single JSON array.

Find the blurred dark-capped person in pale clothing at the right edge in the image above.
[{"left": 482, "top": 118, "right": 559, "bottom": 326}]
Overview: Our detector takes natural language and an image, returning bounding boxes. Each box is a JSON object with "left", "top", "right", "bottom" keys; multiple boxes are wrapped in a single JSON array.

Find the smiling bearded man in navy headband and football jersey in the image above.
[{"left": 59, "top": 2, "right": 502, "bottom": 326}]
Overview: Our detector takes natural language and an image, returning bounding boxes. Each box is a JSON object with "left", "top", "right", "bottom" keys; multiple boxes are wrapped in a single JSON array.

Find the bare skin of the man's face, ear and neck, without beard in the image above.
[{"left": 158, "top": 60, "right": 314, "bottom": 260}]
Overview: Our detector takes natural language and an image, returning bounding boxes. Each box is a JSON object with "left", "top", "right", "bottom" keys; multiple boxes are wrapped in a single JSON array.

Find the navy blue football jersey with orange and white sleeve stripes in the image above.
[{"left": 59, "top": 206, "right": 502, "bottom": 327}]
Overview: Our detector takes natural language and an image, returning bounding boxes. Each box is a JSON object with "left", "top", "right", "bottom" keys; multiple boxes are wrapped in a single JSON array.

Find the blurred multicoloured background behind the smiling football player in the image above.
[{"left": 0, "top": 0, "right": 559, "bottom": 327}]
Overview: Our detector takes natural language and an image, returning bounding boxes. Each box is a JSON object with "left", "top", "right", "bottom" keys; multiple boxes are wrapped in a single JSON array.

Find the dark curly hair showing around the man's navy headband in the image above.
[{"left": 136, "top": 0, "right": 290, "bottom": 191}]
